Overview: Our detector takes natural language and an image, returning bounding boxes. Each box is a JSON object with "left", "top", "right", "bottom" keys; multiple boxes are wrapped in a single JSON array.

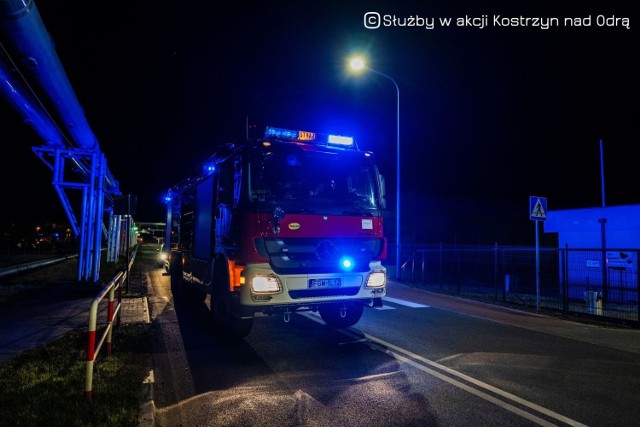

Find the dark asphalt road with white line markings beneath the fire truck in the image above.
[{"left": 137, "top": 251, "right": 640, "bottom": 426}]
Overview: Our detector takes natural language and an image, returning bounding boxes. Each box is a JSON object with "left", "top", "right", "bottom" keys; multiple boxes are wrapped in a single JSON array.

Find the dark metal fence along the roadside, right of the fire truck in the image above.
[{"left": 400, "top": 245, "right": 640, "bottom": 323}]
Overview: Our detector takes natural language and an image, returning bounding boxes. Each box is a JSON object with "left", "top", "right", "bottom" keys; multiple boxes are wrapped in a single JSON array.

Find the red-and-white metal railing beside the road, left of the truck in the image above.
[{"left": 84, "top": 247, "right": 138, "bottom": 400}]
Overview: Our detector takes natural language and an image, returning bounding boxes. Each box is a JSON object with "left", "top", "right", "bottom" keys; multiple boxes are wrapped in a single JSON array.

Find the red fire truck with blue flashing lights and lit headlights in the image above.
[{"left": 166, "top": 127, "right": 387, "bottom": 337}]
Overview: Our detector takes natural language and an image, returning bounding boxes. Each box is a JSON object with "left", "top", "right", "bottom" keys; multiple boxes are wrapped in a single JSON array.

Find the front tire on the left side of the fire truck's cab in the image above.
[{"left": 211, "top": 264, "right": 253, "bottom": 339}]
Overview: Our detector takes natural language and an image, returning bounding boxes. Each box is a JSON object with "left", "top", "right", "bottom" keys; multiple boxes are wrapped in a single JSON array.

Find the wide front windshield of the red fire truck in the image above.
[{"left": 249, "top": 149, "right": 379, "bottom": 214}]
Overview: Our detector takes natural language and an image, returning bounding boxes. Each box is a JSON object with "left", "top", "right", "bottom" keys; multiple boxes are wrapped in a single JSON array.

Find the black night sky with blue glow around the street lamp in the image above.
[{"left": 0, "top": 0, "right": 640, "bottom": 244}]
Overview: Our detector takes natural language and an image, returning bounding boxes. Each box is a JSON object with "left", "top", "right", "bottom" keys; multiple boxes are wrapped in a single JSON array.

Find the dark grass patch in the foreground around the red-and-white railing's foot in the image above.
[{"left": 0, "top": 324, "right": 151, "bottom": 427}]
